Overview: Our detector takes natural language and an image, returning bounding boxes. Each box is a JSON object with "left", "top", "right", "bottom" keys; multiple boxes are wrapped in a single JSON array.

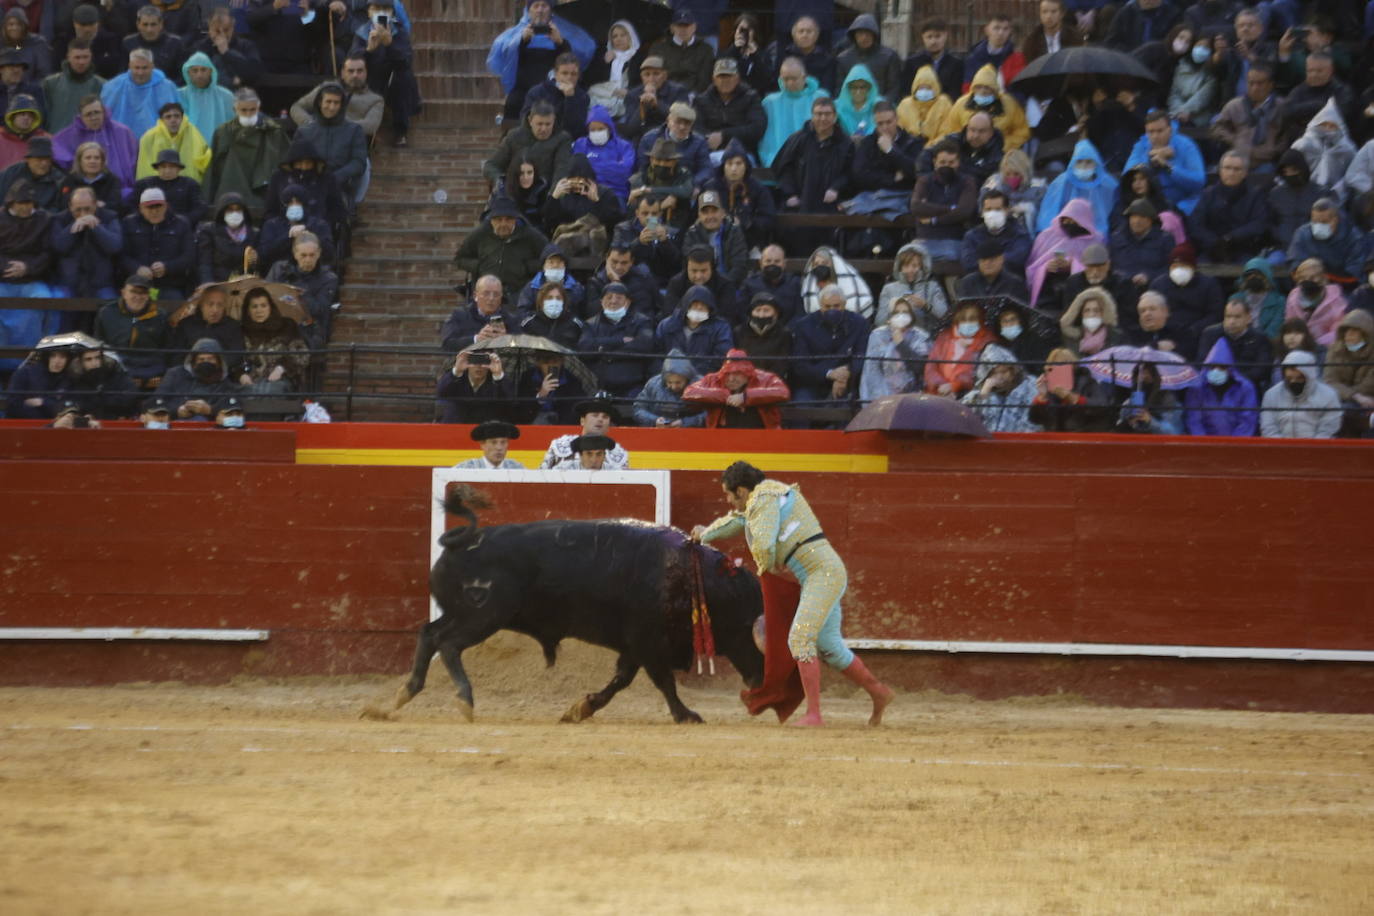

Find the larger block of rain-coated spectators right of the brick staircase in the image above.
[{"left": 437, "top": 0, "right": 1374, "bottom": 438}]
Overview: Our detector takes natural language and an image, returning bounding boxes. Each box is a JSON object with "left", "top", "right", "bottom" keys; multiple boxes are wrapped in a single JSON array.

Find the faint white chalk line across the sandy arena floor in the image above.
[{"left": 7, "top": 724, "right": 1374, "bottom": 780}]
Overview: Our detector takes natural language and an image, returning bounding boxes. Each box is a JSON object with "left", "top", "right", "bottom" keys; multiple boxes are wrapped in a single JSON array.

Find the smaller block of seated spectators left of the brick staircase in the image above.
[{"left": 0, "top": 0, "right": 419, "bottom": 422}]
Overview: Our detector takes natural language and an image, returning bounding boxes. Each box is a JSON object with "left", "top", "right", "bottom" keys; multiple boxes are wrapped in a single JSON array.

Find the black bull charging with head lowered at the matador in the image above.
[{"left": 381, "top": 490, "right": 764, "bottom": 722}]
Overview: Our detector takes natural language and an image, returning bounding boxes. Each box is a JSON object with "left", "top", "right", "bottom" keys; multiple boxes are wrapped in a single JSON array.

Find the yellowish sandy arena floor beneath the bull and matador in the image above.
[{"left": 0, "top": 636, "right": 1374, "bottom": 916}]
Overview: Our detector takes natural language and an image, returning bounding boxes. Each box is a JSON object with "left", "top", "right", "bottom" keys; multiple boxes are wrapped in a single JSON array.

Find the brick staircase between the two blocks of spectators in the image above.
[{"left": 324, "top": 0, "right": 517, "bottom": 420}]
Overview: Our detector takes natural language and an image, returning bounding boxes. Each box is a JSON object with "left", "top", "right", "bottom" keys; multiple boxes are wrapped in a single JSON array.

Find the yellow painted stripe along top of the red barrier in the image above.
[{"left": 295, "top": 449, "right": 888, "bottom": 474}]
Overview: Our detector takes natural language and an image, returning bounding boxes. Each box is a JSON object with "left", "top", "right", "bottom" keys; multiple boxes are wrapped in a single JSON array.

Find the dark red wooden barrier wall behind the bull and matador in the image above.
[{"left": 0, "top": 430, "right": 1374, "bottom": 711}]
